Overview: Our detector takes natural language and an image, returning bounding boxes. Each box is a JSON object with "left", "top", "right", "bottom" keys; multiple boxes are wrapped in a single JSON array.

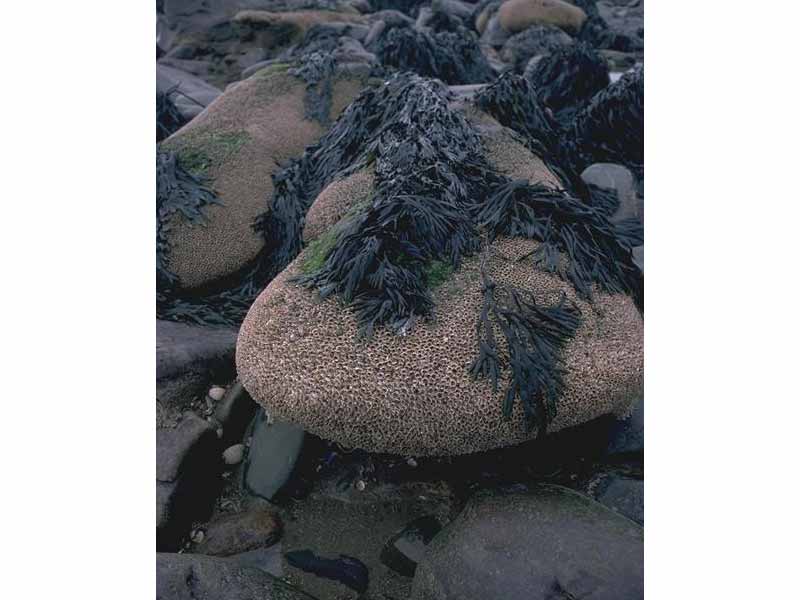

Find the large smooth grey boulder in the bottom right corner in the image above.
[{"left": 412, "top": 485, "right": 644, "bottom": 600}]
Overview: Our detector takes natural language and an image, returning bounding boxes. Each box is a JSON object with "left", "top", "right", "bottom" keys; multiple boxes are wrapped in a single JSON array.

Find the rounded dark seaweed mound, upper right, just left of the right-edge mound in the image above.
[{"left": 526, "top": 42, "right": 609, "bottom": 126}]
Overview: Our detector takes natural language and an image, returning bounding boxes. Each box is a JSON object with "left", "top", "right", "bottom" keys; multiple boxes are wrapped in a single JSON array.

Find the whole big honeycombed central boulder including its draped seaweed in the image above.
[{"left": 237, "top": 73, "right": 642, "bottom": 455}]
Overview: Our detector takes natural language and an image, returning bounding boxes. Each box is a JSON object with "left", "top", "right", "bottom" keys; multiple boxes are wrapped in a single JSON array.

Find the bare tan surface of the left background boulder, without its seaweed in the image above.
[{"left": 161, "top": 64, "right": 372, "bottom": 289}]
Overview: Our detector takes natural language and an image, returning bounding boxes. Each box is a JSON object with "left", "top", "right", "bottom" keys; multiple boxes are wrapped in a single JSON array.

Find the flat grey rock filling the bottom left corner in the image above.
[{"left": 156, "top": 553, "right": 314, "bottom": 600}]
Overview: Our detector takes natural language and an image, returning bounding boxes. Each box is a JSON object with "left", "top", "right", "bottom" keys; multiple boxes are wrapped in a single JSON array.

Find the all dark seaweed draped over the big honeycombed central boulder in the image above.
[{"left": 261, "top": 73, "right": 638, "bottom": 432}]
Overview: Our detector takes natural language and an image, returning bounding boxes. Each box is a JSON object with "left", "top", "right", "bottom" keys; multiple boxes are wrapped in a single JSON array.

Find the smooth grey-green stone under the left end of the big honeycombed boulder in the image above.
[{"left": 245, "top": 409, "right": 305, "bottom": 500}]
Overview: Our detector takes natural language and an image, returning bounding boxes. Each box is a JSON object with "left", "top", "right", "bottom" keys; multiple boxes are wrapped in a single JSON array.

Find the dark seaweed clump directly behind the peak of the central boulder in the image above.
[{"left": 376, "top": 27, "right": 494, "bottom": 85}]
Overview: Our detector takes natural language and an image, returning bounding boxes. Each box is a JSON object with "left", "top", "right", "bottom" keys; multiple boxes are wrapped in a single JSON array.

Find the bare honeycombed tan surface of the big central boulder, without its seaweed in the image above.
[{"left": 236, "top": 76, "right": 643, "bottom": 455}]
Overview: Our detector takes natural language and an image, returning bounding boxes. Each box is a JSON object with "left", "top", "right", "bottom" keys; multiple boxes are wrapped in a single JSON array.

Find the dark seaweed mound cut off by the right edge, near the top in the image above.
[{"left": 572, "top": 67, "right": 644, "bottom": 179}]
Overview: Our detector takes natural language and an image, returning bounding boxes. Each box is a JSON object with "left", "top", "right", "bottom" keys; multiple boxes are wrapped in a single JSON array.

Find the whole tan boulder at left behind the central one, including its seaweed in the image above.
[{"left": 157, "top": 55, "right": 374, "bottom": 324}]
